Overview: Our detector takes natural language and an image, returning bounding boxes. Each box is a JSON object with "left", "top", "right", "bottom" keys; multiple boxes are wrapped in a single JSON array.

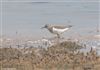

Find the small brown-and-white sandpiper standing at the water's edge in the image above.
[{"left": 42, "top": 24, "right": 72, "bottom": 38}]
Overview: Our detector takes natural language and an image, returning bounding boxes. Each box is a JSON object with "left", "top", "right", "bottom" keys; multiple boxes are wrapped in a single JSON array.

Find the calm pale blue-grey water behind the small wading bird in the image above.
[{"left": 2, "top": 1, "right": 99, "bottom": 39}]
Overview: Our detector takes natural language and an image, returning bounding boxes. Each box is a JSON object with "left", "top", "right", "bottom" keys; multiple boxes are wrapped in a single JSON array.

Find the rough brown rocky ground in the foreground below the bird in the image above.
[{"left": 0, "top": 41, "right": 100, "bottom": 70}]
